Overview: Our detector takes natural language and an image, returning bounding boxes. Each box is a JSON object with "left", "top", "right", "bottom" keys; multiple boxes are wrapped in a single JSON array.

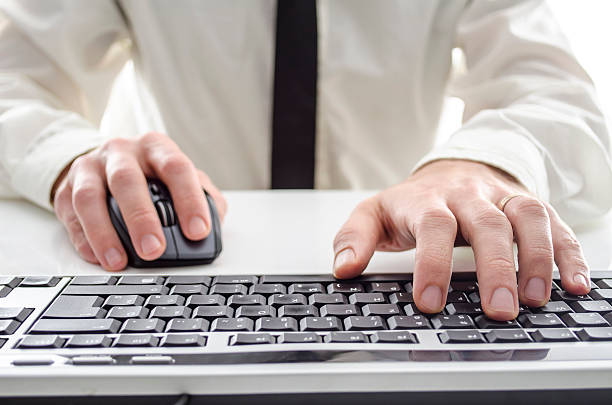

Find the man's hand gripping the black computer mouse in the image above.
[{"left": 52, "top": 133, "right": 227, "bottom": 271}]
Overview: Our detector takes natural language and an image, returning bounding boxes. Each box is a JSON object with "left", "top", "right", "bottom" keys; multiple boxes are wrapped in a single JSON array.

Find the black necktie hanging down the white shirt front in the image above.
[{"left": 272, "top": 0, "right": 317, "bottom": 188}]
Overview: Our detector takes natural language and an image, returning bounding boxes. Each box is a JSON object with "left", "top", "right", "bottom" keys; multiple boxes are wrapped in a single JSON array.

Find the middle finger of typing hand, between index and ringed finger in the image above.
[{"left": 450, "top": 200, "right": 518, "bottom": 321}]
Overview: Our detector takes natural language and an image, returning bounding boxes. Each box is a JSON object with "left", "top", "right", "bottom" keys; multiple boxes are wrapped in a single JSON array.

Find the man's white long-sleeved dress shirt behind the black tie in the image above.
[{"left": 0, "top": 0, "right": 612, "bottom": 223}]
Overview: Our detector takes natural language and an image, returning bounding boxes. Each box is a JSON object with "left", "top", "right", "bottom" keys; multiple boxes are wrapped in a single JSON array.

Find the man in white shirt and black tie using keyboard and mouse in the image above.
[{"left": 0, "top": 0, "right": 612, "bottom": 320}]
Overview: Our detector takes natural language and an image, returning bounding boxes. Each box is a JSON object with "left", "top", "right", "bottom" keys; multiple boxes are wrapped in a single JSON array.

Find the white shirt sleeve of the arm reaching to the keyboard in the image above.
[{"left": 414, "top": 0, "right": 612, "bottom": 224}]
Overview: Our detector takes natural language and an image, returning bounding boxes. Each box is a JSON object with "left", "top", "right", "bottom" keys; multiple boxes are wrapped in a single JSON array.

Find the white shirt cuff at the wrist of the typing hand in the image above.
[{"left": 412, "top": 128, "right": 550, "bottom": 201}]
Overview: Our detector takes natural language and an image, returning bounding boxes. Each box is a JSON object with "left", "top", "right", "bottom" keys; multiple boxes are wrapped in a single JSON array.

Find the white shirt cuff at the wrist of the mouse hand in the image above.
[{"left": 12, "top": 129, "right": 106, "bottom": 211}]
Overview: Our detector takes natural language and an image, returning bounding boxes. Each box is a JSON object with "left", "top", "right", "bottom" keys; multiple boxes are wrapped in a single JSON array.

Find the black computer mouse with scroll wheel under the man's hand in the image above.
[{"left": 107, "top": 179, "right": 221, "bottom": 267}]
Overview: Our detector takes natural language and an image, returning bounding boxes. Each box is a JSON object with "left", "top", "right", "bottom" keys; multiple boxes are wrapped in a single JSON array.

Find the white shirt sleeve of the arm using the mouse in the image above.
[{"left": 0, "top": 0, "right": 129, "bottom": 209}]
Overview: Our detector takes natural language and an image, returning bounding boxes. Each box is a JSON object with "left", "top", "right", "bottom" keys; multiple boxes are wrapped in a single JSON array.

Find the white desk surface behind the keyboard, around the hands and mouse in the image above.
[{"left": 0, "top": 191, "right": 612, "bottom": 275}]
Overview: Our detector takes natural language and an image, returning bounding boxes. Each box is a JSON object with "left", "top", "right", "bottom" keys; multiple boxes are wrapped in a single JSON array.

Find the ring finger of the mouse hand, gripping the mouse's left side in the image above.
[{"left": 68, "top": 158, "right": 127, "bottom": 271}]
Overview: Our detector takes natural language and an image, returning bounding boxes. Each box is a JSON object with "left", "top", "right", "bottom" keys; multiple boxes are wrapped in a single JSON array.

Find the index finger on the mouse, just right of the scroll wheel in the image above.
[{"left": 142, "top": 135, "right": 211, "bottom": 240}]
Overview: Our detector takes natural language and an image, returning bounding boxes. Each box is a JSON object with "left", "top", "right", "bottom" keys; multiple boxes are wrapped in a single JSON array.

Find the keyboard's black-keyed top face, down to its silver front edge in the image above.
[{"left": 0, "top": 272, "right": 612, "bottom": 365}]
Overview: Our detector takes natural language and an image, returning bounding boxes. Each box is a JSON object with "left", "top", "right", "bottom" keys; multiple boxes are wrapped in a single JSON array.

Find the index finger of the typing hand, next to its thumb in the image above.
[{"left": 407, "top": 205, "right": 457, "bottom": 313}]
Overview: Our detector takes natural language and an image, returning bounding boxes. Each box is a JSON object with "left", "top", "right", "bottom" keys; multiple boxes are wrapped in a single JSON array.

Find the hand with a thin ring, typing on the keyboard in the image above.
[{"left": 334, "top": 160, "right": 590, "bottom": 321}]
